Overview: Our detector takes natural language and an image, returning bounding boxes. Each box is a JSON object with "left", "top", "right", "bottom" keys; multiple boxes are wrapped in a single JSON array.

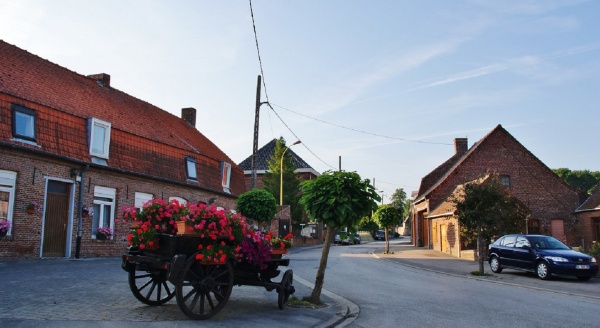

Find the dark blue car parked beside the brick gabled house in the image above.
[{"left": 488, "top": 234, "right": 598, "bottom": 281}]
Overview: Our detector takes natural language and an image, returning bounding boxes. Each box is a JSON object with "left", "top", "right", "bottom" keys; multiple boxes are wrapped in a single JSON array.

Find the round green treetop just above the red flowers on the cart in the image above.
[{"left": 237, "top": 189, "right": 277, "bottom": 223}]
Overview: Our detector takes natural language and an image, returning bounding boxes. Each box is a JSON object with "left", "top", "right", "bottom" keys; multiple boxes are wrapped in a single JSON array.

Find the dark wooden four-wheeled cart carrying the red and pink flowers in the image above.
[{"left": 121, "top": 234, "right": 295, "bottom": 320}]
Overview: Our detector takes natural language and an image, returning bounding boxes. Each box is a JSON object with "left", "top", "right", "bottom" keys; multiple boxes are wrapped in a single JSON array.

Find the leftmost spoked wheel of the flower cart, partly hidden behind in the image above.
[{"left": 129, "top": 266, "right": 175, "bottom": 306}]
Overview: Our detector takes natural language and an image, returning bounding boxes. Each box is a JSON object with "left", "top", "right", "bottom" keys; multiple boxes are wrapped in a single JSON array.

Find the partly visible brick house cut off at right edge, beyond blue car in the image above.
[{"left": 575, "top": 183, "right": 600, "bottom": 248}]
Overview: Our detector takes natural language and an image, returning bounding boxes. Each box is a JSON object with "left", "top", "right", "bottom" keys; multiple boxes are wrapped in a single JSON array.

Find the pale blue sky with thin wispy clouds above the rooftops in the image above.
[{"left": 0, "top": 0, "right": 600, "bottom": 203}]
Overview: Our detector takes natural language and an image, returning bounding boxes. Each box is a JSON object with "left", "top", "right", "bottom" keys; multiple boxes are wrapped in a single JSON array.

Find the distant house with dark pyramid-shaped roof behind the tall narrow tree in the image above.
[{"left": 239, "top": 139, "right": 322, "bottom": 244}]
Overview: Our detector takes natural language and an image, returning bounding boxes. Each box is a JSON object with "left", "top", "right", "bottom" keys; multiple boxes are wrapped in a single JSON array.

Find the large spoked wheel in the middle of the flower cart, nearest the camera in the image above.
[{"left": 176, "top": 255, "right": 233, "bottom": 320}]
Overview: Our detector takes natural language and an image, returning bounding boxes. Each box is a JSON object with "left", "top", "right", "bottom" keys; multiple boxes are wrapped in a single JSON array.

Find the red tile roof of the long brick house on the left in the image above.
[{"left": 0, "top": 40, "right": 245, "bottom": 194}]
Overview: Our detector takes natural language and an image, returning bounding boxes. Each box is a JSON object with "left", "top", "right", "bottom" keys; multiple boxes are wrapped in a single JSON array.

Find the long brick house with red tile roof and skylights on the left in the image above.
[{"left": 0, "top": 40, "right": 246, "bottom": 257}]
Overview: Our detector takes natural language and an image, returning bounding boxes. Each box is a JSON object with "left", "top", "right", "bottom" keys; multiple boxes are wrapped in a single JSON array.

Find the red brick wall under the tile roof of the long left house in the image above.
[{"left": 0, "top": 147, "right": 235, "bottom": 257}]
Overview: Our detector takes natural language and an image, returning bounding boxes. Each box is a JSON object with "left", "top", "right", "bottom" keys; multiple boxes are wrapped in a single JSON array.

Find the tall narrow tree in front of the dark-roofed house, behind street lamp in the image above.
[{"left": 262, "top": 137, "right": 304, "bottom": 227}]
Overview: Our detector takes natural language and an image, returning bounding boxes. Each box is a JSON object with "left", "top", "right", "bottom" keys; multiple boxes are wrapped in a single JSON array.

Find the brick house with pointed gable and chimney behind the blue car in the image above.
[{"left": 412, "top": 125, "right": 582, "bottom": 258}]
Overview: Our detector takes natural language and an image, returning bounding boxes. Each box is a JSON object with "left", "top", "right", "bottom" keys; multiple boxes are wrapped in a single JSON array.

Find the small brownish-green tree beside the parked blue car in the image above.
[{"left": 451, "top": 176, "right": 526, "bottom": 274}]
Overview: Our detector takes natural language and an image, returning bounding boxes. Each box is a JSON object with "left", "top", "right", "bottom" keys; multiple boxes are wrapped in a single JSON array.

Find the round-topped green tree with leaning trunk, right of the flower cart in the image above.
[{"left": 300, "top": 171, "right": 381, "bottom": 304}]
